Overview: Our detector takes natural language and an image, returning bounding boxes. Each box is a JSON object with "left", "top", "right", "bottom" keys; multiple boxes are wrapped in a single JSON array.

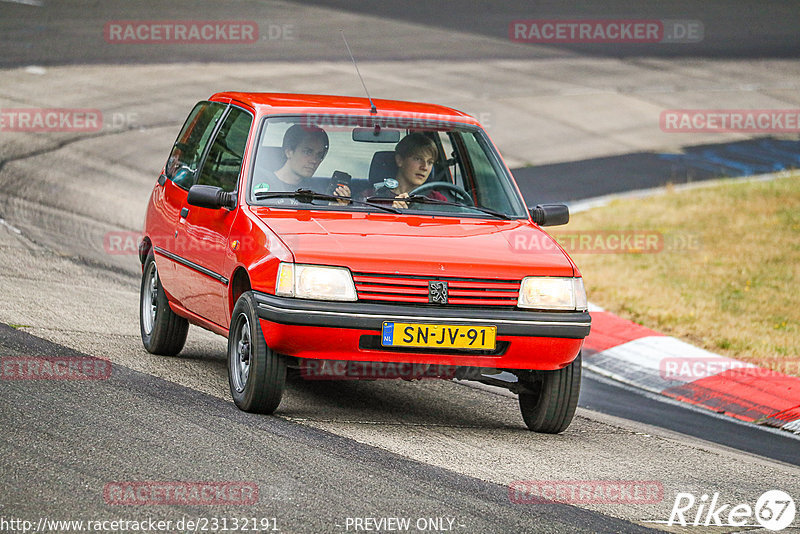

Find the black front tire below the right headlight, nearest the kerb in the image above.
[{"left": 519, "top": 353, "right": 581, "bottom": 434}]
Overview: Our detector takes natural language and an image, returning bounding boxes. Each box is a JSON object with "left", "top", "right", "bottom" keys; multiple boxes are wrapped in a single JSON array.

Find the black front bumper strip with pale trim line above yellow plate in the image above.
[{"left": 253, "top": 291, "right": 592, "bottom": 339}]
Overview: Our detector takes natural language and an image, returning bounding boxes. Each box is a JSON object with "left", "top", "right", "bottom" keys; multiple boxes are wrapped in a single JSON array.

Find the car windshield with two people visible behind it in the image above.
[{"left": 248, "top": 115, "right": 527, "bottom": 218}]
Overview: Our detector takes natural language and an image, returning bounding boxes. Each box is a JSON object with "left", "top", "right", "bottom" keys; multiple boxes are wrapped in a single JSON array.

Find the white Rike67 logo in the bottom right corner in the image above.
[{"left": 652, "top": 490, "right": 796, "bottom": 531}]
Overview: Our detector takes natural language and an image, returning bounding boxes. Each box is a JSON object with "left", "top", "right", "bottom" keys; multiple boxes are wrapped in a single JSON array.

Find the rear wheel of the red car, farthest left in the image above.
[{"left": 139, "top": 252, "right": 189, "bottom": 356}]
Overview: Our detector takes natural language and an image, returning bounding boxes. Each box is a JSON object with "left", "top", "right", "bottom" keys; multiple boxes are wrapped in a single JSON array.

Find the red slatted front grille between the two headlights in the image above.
[{"left": 353, "top": 273, "right": 520, "bottom": 308}]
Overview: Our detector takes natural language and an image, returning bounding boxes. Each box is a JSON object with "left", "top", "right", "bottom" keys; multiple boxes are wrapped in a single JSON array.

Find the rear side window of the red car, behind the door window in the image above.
[{"left": 166, "top": 102, "right": 226, "bottom": 189}]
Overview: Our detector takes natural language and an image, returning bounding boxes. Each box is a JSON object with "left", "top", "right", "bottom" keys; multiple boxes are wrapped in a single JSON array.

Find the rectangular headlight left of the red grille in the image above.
[{"left": 275, "top": 263, "right": 358, "bottom": 301}]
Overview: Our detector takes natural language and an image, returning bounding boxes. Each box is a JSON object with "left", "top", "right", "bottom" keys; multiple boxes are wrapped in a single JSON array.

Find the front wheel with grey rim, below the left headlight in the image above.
[{"left": 228, "top": 291, "right": 286, "bottom": 414}]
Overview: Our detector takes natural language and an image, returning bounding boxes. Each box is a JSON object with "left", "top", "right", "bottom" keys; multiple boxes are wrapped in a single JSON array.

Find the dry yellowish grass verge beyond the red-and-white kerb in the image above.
[{"left": 564, "top": 173, "right": 800, "bottom": 376}]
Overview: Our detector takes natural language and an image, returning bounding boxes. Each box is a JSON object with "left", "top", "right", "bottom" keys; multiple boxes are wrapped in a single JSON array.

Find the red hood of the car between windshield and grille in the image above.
[{"left": 253, "top": 207, "right": 575, "bottom": 279}]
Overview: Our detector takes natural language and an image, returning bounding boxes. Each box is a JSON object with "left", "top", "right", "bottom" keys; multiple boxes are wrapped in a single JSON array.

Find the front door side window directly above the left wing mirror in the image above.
[{"left": 197, "top": 107, "right": 253, "bottom": 191}]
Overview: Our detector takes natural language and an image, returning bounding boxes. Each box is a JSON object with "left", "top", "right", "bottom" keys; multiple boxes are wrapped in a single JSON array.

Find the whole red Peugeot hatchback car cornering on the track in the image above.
[{"left": 139, "top": 92, "right": 590, "bottom": 433}]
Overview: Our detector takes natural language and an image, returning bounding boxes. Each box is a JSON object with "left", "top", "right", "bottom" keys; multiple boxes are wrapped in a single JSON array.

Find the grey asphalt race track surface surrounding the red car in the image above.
[{"left": 0, "top": 0, "right": 800, "bottom": 533}]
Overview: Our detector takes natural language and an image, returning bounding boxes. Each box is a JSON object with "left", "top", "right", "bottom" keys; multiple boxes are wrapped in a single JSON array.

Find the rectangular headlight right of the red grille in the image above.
[{"left": 517, "top": 276, "right": 587, "bottom": 311}]
